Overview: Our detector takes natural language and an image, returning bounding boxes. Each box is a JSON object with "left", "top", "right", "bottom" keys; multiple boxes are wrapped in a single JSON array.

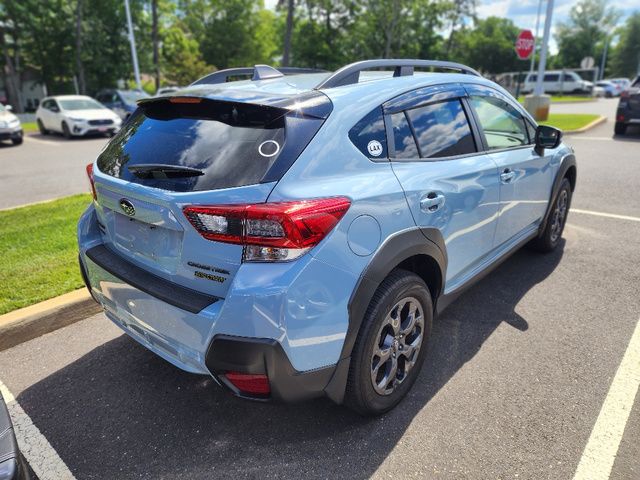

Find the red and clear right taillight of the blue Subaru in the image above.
[{"left": 184, "top": 197, "right": 351, "bottom": 262}]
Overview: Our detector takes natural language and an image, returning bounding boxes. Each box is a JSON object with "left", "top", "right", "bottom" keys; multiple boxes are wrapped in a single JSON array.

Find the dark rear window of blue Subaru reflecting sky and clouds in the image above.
[{"left": 97, "top": 99, "right": 287, "bottom": 191}]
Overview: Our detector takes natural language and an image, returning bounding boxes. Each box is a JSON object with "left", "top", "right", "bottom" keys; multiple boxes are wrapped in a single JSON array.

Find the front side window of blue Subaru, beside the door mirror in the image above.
[{"left": 471, "top": 97, "right": 529, "bottom": 150}]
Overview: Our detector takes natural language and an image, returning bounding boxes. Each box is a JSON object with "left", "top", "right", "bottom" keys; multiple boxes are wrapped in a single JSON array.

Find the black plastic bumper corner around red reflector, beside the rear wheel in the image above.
[{"left": 206, "top": 335, "right": 335, "bottom": 402}]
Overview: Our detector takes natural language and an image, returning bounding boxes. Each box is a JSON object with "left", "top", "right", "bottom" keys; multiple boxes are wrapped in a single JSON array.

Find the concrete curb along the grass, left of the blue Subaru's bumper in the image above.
[{"left": 0, "top": 289, "right": 102, "bottom": 351}]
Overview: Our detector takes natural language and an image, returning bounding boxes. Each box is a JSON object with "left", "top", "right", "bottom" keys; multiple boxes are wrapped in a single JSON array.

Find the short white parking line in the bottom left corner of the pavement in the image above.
[{"left": 0, "top": 381, "right": 75, "bottom": 480}]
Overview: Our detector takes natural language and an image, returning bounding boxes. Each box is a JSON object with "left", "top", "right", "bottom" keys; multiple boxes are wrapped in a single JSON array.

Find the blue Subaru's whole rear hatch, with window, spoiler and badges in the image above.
[{"left": 93, "top": 92, "right": 331, "bottom": 297}]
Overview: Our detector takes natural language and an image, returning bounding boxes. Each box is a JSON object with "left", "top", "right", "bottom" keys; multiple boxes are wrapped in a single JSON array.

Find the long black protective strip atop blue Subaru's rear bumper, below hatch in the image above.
[{"left": 86, "top": 245, "right": 220, "bottom": 313}]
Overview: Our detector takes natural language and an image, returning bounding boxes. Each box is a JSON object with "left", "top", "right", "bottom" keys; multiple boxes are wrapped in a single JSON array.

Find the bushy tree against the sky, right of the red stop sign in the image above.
[{"left": 556, "top": 0, "right": 620, "bottom": 67}]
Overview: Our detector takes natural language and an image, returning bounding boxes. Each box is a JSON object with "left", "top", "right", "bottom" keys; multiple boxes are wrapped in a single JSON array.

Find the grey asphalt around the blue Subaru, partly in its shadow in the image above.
[{"left": 0, "top": 99, "right": 640, "bottom": 480}]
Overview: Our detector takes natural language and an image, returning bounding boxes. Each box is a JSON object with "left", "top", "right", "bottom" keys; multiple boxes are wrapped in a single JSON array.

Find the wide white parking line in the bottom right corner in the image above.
[{"left": 573, "top": 320, "right": 640, "bottom": 480}]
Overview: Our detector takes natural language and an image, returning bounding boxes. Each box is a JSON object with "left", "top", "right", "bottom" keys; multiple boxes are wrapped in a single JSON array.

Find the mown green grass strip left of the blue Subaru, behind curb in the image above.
[{"left": 0, "top": 194, "right": 91, "bottom": 314}]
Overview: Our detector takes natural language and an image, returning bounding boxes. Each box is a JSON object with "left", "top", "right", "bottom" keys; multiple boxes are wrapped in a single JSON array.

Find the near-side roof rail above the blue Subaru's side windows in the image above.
[{"left": 316, "top": 59, "right": 481, "bottom": 89}]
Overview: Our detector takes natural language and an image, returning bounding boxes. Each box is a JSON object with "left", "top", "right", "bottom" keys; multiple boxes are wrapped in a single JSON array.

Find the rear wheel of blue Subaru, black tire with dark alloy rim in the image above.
[{"left": 345, "top": 269, "right": 433, "bottom": 415}]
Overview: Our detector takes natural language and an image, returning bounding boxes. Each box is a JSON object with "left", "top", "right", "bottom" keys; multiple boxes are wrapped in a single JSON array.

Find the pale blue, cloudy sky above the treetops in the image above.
[{"left": 265, "top": 0, "right": 640, "bottom": 54}]
